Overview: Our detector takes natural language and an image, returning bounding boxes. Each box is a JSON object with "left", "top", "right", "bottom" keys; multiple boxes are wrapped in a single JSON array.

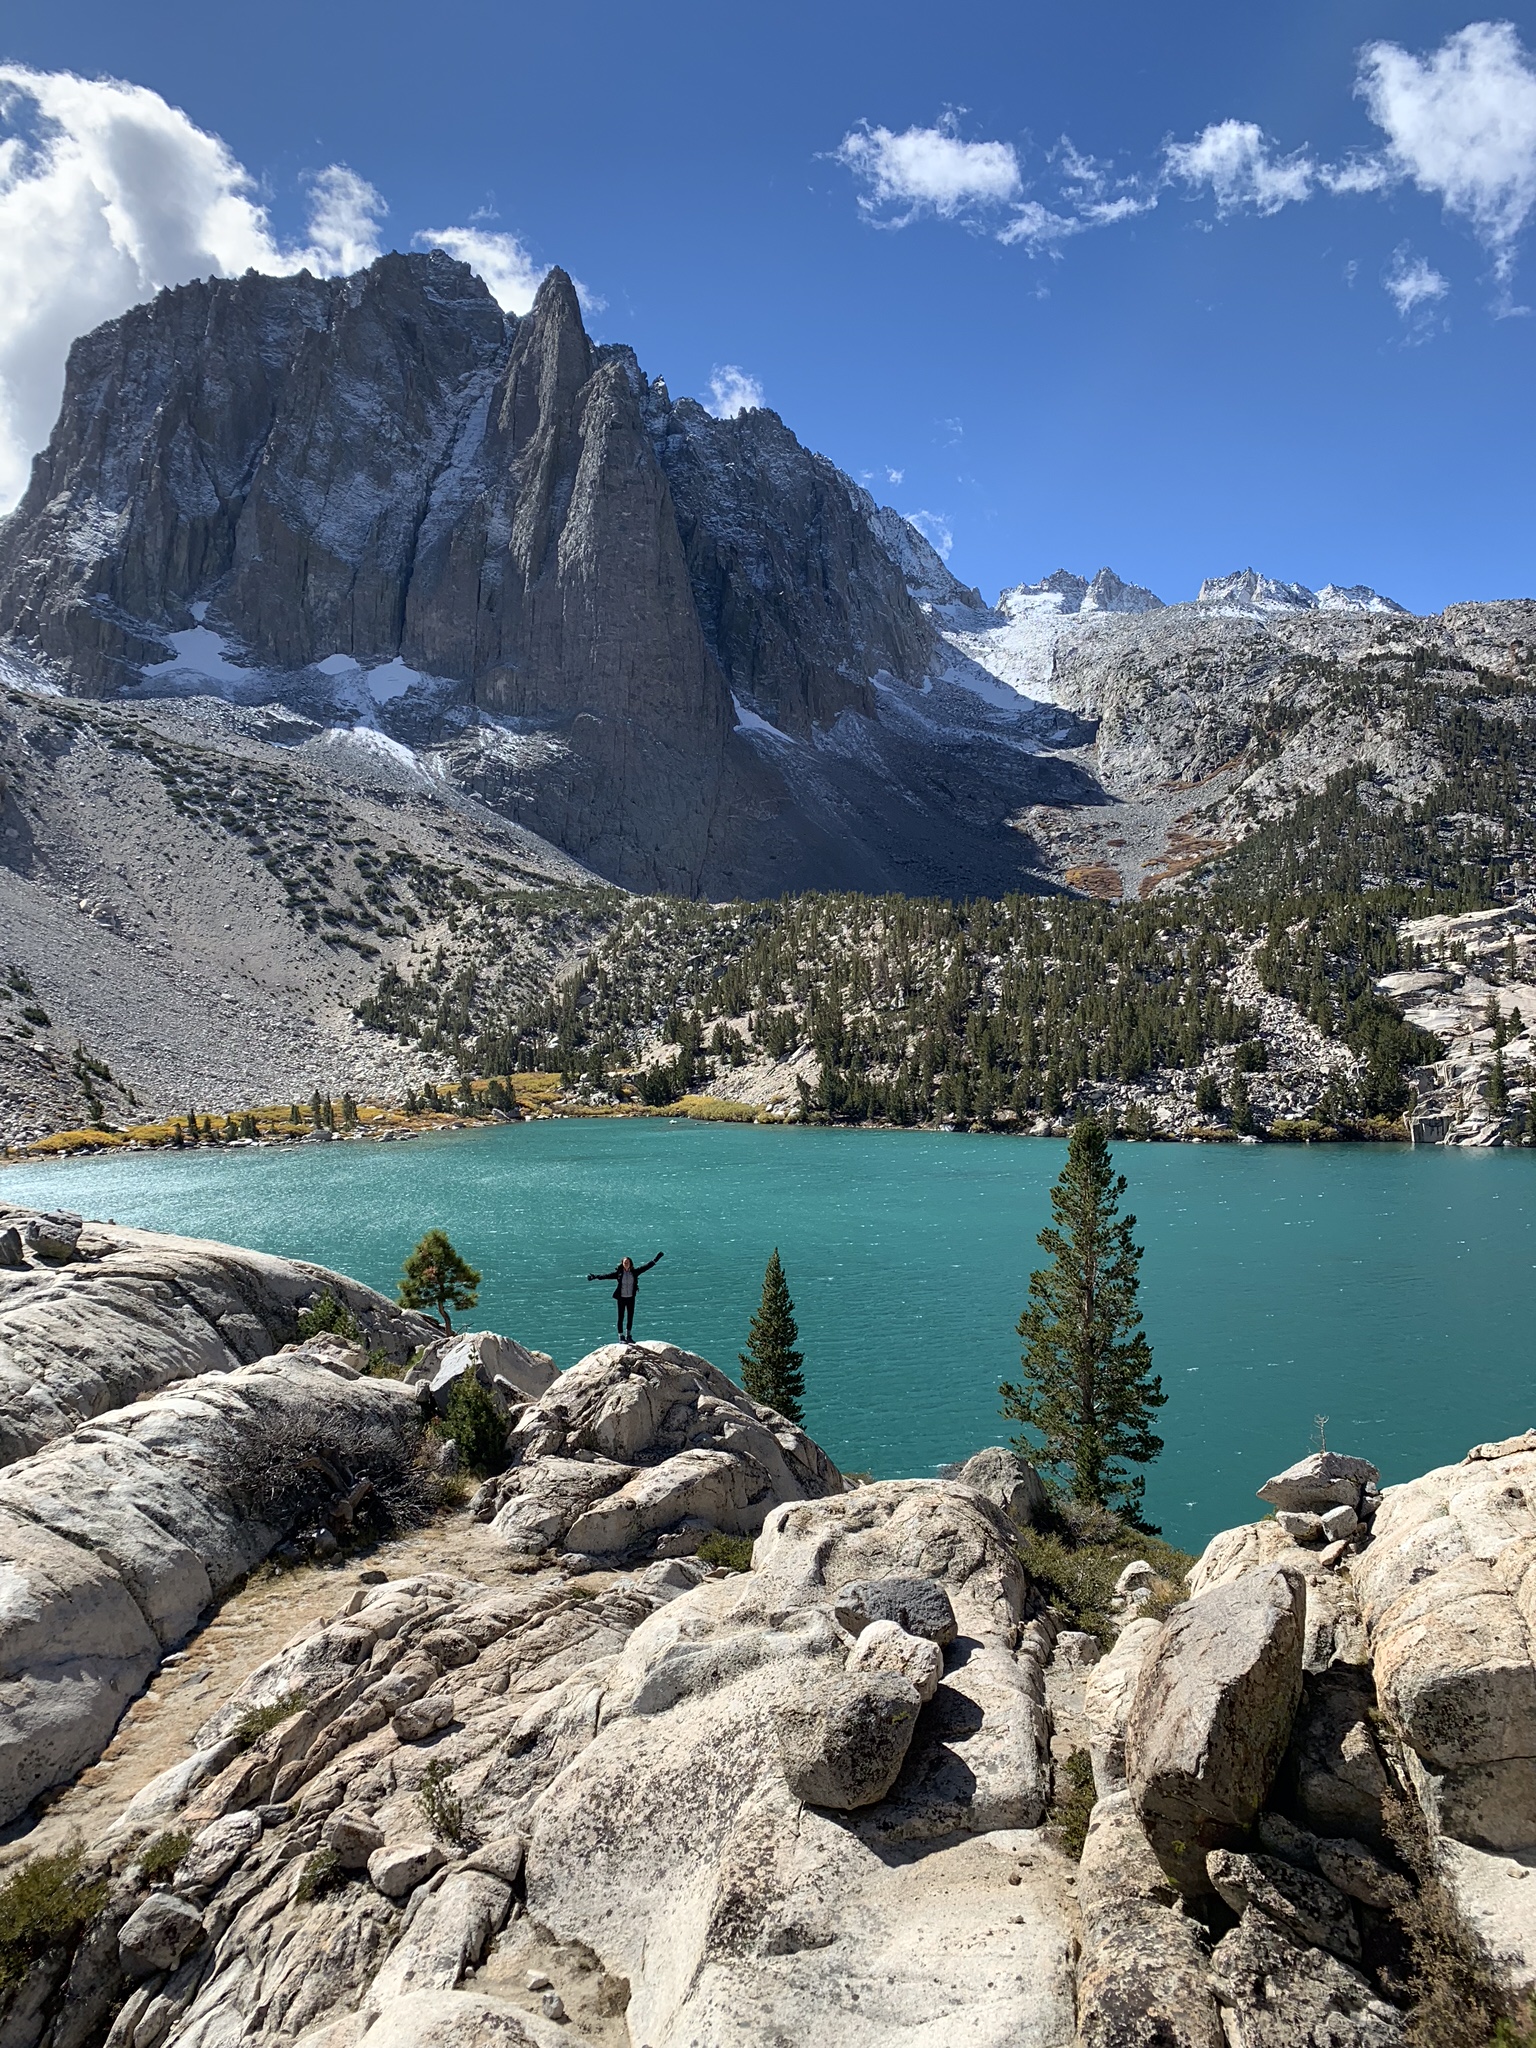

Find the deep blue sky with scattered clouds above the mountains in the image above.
[{"left": 0, "top": 0, "right": 1536, "bottom": 610}]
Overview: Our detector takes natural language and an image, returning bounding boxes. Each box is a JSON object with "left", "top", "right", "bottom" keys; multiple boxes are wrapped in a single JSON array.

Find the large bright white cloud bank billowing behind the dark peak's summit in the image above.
[{"left": 0, "top": 63, "right": 581, "bottom": 514}]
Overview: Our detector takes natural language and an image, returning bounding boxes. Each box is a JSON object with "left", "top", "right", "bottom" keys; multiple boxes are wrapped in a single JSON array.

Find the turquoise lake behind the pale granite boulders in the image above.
[{"left": 0, "top": 1120, "right": 1536, "bottom": 1548}]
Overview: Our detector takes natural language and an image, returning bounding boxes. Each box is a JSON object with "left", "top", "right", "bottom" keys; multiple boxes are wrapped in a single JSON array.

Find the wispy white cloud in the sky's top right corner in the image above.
[{"left": 1356, "top": 20, "right": 1536, "bottom": 279}]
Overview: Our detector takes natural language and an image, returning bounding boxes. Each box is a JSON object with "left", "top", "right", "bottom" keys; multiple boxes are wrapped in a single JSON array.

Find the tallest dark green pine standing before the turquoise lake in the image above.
[{"left": 997, "top": 1120, "right": 1167, "bottom": 1516}]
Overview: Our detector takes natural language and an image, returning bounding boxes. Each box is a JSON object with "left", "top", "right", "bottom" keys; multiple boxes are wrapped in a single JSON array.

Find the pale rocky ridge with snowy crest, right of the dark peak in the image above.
[{"left": 930, "top": 580, "right": 1536, "bottom": 895}]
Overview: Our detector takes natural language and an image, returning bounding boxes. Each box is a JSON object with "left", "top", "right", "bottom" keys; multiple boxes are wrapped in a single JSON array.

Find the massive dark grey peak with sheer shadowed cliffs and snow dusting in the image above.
[{"left": 0, "top": 254, "right": 1092, "bottom": 895}]
